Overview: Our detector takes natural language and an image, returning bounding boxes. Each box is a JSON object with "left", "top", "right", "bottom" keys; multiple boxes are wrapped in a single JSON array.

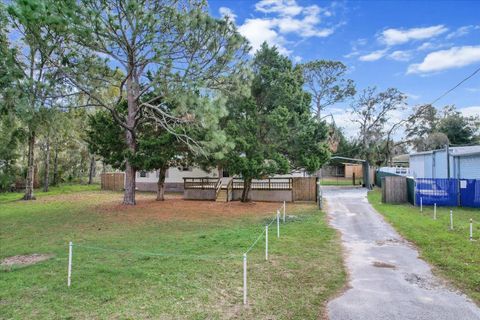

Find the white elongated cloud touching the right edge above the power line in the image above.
[{"left": 407, "top": 46, "right": 480, "bottom": 74}]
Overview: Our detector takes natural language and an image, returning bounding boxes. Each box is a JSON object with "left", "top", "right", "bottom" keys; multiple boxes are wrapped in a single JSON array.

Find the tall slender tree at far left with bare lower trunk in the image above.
[{"left": 8, "top": 1, "right": 68, "bottom": 200}]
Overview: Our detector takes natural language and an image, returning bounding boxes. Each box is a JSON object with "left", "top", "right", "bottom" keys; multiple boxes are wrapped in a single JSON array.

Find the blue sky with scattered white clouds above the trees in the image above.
[{"left": 209, "top": 0, "right": 480, "bottom": 136}]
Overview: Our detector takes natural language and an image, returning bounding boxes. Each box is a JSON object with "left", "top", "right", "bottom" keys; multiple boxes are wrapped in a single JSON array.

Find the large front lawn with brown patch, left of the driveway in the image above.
[{"left": 0, "top": 191, "right": 346, "bottom": 319}]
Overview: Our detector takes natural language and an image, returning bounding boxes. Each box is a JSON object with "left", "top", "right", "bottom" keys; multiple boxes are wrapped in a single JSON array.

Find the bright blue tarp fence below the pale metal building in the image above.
[{"left": 415, "top": 178, "right": 480, "bottom": 208}]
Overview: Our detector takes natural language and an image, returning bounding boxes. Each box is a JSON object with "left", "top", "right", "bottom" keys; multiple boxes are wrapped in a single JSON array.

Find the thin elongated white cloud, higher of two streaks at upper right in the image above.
[{"left": 380, "top": 25, "right": 448, "bottom": 46}]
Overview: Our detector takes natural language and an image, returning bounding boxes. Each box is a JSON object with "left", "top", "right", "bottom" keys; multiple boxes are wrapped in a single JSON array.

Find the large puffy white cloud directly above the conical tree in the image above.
[{"left": 238, "top": 0, "right": 335, "bottom": 54}]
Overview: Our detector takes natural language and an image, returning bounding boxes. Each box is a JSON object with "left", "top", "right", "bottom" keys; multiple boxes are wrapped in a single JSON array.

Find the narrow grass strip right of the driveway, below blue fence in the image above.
[{"left": 368, "top": 189, "right": 480, "bottom": 304}]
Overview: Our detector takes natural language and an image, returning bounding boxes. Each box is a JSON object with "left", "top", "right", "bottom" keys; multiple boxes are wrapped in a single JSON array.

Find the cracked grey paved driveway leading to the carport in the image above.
[{"left": 322, "top": 187, "right": 480, "bottom": 320}]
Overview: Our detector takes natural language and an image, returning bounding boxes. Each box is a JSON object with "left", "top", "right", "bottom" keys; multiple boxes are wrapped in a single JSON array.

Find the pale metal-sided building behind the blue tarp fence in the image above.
[{"left": 410, "top": 145, "right": 480, "bottom": 179}]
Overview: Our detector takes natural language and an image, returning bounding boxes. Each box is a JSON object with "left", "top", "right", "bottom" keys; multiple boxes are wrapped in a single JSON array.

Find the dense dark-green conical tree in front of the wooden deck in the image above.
[{"left": 224, "top": 43, "right": 329, "bottom": 202}]
